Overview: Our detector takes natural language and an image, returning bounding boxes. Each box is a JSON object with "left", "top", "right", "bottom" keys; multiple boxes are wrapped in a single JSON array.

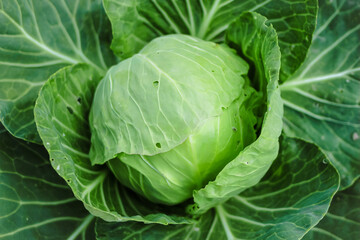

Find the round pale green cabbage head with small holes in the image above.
[{"left": 90, "top": 34, "right": 257, "bottom": 205}]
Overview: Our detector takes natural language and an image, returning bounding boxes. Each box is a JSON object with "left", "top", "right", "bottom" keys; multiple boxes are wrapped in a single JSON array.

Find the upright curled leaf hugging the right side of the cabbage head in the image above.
[{"left": 189, "top": 12, "right": 283, "bottom": 214}]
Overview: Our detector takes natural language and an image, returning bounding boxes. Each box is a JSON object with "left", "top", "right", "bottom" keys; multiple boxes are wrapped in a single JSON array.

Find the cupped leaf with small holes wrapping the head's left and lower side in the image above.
[{"left": 35, "top": 64, "right": 191, "bottom": 224}]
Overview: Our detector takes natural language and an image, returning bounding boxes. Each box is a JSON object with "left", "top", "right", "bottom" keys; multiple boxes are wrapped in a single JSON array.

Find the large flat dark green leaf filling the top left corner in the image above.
[{"left": 0, "top": 0, "right": 114, "bottom": 143}]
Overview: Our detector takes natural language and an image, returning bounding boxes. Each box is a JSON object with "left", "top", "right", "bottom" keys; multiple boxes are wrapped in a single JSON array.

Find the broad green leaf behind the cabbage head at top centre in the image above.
[{"left": 104, "top": 0, "right": 317, "bottom": 79}]
